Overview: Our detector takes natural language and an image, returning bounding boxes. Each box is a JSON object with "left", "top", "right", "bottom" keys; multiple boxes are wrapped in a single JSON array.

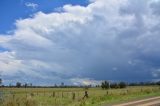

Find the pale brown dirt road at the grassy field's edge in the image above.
[{"left": 113, "top": 96, "right": 160, "bottom": 106}]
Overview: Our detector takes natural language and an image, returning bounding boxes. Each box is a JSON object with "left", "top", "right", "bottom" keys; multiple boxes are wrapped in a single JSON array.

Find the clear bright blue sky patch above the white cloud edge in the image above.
[{"left": 0, "top": 0, "right": 88, "bottom": 34}]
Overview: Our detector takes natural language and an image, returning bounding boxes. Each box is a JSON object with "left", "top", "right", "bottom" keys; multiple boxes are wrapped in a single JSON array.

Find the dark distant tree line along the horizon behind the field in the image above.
[{"left": 0, "top": 78, "right": 160, "bottom": 89}]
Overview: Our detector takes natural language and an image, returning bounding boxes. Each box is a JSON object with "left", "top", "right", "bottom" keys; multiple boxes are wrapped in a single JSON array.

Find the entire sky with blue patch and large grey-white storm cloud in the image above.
[{"left": 0, "top": 0, "right": 160, "bottom": 85}]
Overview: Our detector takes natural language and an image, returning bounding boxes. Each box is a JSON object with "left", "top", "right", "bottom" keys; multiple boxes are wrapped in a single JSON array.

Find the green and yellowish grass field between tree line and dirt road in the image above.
[{"left": 0, "top": 86, "right": 160, "bottom": 106}]
